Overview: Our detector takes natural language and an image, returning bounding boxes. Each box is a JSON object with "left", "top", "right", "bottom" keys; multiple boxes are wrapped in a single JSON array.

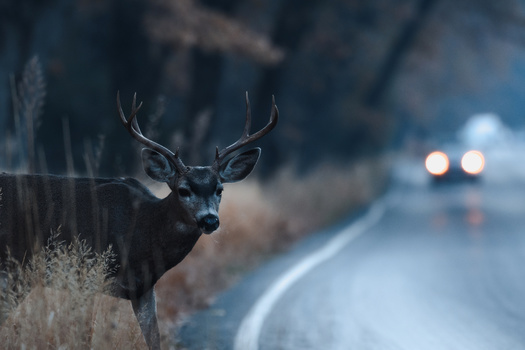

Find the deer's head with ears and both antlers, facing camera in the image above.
[{"left": 117, "top": 93, "right": 279, "bottom": 234}]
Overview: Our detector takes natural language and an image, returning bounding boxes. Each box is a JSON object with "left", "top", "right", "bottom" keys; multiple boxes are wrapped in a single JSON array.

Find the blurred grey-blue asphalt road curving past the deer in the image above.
[{"left": 180, "top": 159, "right": 525, "bottom": 350}]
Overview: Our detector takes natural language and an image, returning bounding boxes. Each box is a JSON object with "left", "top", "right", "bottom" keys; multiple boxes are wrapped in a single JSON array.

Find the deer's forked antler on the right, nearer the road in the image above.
[{"left": 214, "top": 92, "right": 279, "bottom": 168}]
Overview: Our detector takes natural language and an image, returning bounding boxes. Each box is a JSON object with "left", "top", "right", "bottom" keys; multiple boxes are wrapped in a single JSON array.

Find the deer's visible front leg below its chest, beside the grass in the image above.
[{"left": 131, "top": 287, "right": 160, "bottom": 350}]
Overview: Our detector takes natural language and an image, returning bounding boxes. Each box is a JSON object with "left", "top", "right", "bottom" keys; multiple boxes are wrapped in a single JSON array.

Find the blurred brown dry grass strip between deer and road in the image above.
[{"left": 156, "top": 160, "right": 387, "bottom": 334}]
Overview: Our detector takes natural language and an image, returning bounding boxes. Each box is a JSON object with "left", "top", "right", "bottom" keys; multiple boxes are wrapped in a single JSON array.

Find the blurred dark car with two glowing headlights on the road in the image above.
[{"left": 425, "top": 148, "right": 485, "bottom": 183}]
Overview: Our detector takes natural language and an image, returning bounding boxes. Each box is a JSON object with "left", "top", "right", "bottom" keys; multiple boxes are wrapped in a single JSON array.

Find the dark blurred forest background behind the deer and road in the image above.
[{"left": 0, "top": 0, "right": 525, "bottom": 176}]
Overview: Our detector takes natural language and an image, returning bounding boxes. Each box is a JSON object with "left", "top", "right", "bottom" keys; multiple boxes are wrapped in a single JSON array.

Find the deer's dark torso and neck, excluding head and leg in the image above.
[{"left": 0, "top": 174, "right": 201, "bottom": 299}]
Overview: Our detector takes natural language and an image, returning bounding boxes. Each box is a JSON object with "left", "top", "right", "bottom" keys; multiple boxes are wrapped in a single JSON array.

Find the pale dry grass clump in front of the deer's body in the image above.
[{"left": 0, "top": 234, "right": 145, "bottom": 349}]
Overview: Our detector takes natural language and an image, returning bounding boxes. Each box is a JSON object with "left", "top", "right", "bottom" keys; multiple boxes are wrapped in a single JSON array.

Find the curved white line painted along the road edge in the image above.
[{"left": 234, "top": 201, "right": 385, "bottom": 350}]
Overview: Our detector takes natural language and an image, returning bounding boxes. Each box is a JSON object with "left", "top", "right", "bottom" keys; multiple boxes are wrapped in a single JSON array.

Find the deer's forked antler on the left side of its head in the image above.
[{"left": 117, "top": 91, "right": 186, "bottom": 173}]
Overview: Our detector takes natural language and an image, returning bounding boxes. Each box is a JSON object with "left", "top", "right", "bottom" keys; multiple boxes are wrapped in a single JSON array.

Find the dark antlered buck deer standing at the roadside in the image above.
[{"left": 0, "top": 93, "right": 278, "bottom": 349}]
